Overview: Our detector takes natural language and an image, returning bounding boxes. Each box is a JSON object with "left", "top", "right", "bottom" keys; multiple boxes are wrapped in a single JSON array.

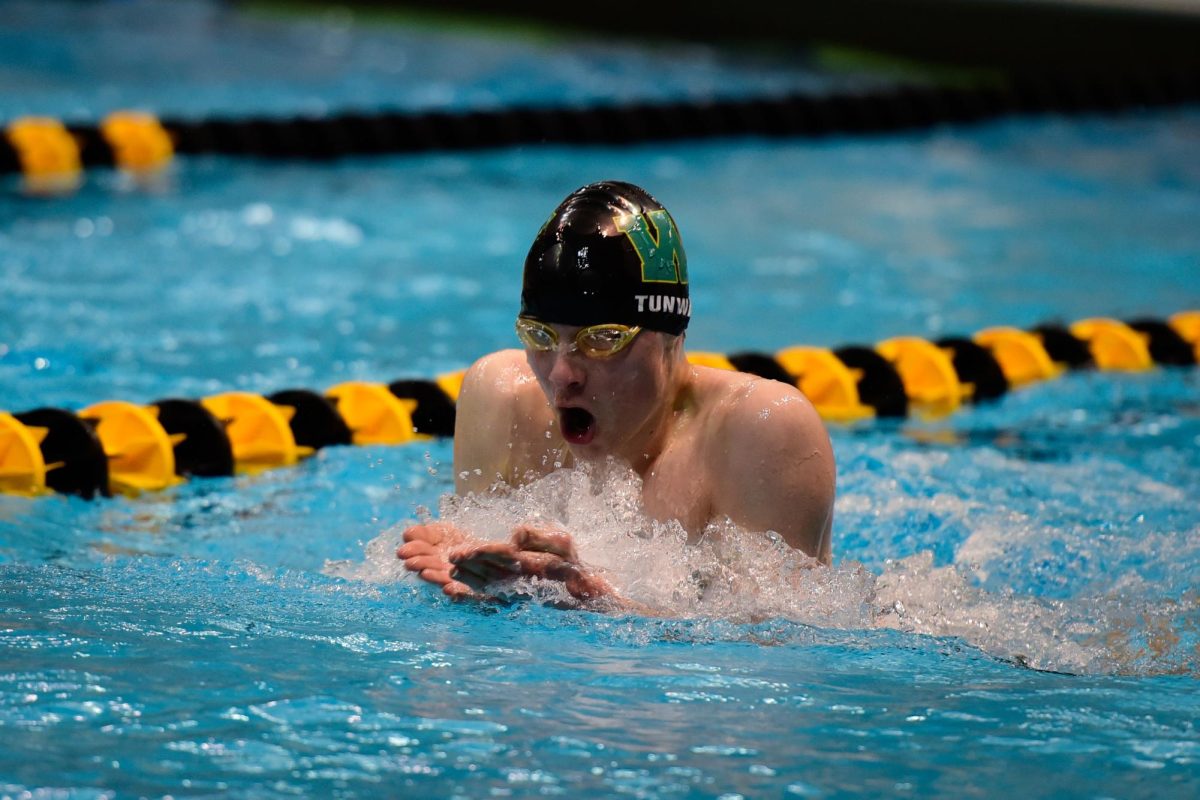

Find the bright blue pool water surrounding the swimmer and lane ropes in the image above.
[{"left": 0, "top": 2, "right": 1200, "bottom": 798}]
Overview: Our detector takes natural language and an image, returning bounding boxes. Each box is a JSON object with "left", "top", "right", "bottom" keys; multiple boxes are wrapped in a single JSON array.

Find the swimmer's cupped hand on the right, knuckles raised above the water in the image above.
[{"left": 446, "top": 525, "right": 616, "bottom": 604}]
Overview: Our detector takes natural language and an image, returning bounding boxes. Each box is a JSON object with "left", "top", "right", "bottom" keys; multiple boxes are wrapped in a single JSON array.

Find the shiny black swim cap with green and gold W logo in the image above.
[{"left": 521, "top": 181, "right": 691, "bottom": 335}]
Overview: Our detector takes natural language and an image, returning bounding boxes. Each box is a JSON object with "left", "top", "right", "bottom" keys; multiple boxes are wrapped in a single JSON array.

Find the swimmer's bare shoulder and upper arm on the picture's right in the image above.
[{"left": 712, "top": 380, "right": 836, "bottom": 564}]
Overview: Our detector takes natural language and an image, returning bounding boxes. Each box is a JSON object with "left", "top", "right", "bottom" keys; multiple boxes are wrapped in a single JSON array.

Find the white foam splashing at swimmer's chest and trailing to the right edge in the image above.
[{"left": 336, "top": 463, "right": 1200, "bottom": 674}]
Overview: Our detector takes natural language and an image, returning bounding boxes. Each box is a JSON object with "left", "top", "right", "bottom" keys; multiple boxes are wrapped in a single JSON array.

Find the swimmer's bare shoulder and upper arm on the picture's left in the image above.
[{"left": 454, "top": 350, "right": 524, "bottom": 495}]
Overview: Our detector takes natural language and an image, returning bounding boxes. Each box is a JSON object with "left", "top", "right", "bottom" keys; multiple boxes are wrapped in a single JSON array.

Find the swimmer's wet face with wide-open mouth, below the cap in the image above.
[{"left": 526, "top": 325, "right": 678, "bottom": 463}]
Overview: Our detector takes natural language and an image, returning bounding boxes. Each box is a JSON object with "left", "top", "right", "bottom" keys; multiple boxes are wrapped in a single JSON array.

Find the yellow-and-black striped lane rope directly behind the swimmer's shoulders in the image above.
[{"left": 0, "top": 311, "right": 1200, "bottom": 499}]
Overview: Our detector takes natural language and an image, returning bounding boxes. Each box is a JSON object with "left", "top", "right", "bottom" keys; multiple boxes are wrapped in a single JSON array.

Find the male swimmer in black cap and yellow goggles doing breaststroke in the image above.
[{"left": 397, "top": 181, "right": 835, "bottom": 607}]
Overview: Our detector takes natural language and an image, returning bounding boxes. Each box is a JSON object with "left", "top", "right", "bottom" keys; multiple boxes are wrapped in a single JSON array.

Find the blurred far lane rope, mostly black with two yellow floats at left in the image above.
[{"left": 0, "top": 68, "right": 1200, "bottom": 193}]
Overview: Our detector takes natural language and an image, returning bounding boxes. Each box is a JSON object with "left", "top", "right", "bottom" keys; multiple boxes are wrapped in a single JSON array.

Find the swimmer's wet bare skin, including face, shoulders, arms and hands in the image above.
[{"left": 397, "top": 325, "right": 834, "bottom": 604}]
